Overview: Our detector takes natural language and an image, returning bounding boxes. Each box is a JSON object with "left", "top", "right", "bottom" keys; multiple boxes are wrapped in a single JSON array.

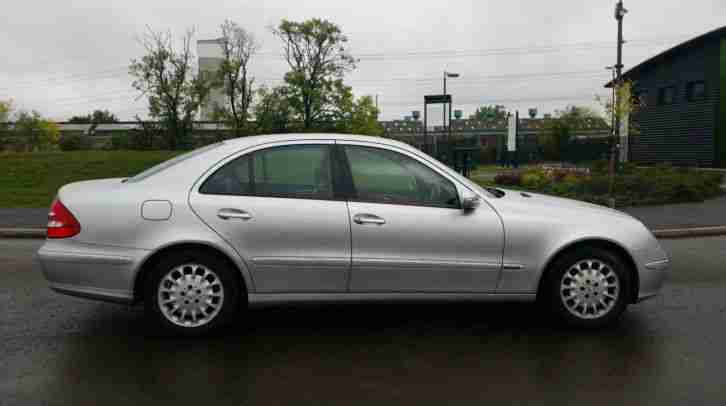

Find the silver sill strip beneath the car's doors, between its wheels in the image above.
[{"left": 248, "top": 292, "right": 537, "bottom": 305}]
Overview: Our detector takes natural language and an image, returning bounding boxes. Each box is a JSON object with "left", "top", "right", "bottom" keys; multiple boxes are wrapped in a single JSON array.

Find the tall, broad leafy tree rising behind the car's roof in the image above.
[{"left": 273, "top": 19, "right": 356, "bottom": 130}]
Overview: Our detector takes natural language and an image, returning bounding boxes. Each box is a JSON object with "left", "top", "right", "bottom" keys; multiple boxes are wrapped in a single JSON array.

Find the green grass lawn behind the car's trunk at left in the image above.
[{"left": 0, "top": 151, "right": 179, "bottom": 207}]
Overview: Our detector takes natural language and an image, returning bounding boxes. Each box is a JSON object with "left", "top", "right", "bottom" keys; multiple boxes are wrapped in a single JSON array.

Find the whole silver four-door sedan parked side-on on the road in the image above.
[{"left": 38, "top": 134, "right": 668, "bottom": 334}]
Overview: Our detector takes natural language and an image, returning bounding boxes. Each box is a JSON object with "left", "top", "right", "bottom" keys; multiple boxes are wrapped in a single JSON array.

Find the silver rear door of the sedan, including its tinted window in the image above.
[{"left": 191, "top": 141, "right": 350, "bottom": 293}]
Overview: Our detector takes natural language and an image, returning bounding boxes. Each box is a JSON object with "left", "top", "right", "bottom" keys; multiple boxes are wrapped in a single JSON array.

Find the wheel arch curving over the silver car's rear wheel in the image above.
[{"left": 132, "top": 241, "right": 252, "bottom": 303}]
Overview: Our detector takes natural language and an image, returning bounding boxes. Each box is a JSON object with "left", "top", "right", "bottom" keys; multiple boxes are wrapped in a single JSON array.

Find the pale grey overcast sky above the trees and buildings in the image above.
[{"left": 0, "top": 0, "right": 726, "bottom": 123}]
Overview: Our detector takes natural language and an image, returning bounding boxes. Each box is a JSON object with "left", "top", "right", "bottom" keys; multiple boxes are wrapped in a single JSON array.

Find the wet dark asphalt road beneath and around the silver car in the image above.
[{"left": 0, "top": 238, "right": 726, "bottom": 406}]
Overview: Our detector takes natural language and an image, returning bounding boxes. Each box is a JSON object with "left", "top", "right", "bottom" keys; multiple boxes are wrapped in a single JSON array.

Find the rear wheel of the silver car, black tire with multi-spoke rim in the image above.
[{"left": 144, "top": 250, "right": 244, "bottom": 336}]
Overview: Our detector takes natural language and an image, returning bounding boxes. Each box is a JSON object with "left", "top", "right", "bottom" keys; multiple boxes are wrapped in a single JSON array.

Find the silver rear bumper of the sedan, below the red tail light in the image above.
[{"left": 38, "top": 239, "right": 149, "bottom": 303}]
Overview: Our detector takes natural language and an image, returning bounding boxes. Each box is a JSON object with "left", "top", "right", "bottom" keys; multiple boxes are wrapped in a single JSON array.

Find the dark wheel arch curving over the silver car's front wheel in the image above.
[{"left": 537, "top": 238, "right": 640, "bottom": 303}]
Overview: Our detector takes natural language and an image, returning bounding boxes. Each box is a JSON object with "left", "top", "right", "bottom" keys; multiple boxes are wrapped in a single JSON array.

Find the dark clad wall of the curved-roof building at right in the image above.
[{"left": 629, "top": 36, "right": 721, "bottom": 166}]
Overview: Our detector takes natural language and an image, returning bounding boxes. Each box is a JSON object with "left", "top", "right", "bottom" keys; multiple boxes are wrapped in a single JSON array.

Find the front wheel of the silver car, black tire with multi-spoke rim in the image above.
[{"left": 547, "top": 247, "right": 632, "bottom": 328}]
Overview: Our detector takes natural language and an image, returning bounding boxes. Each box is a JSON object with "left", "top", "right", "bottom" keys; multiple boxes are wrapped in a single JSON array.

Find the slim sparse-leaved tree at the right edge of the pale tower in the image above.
[{"left": 215, "top": 20, "right": 259, "bottom": 137}]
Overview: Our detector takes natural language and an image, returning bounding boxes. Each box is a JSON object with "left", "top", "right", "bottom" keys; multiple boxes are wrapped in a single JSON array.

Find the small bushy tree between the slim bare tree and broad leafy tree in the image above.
[{"left": 254, "top": 86, "right": 295, "bottom": 134}]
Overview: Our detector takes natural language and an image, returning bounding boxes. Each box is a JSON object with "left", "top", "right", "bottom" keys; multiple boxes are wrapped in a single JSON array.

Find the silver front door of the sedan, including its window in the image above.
[{"left": 339, "top": 143, "right": 504, "bottom": 293}]
